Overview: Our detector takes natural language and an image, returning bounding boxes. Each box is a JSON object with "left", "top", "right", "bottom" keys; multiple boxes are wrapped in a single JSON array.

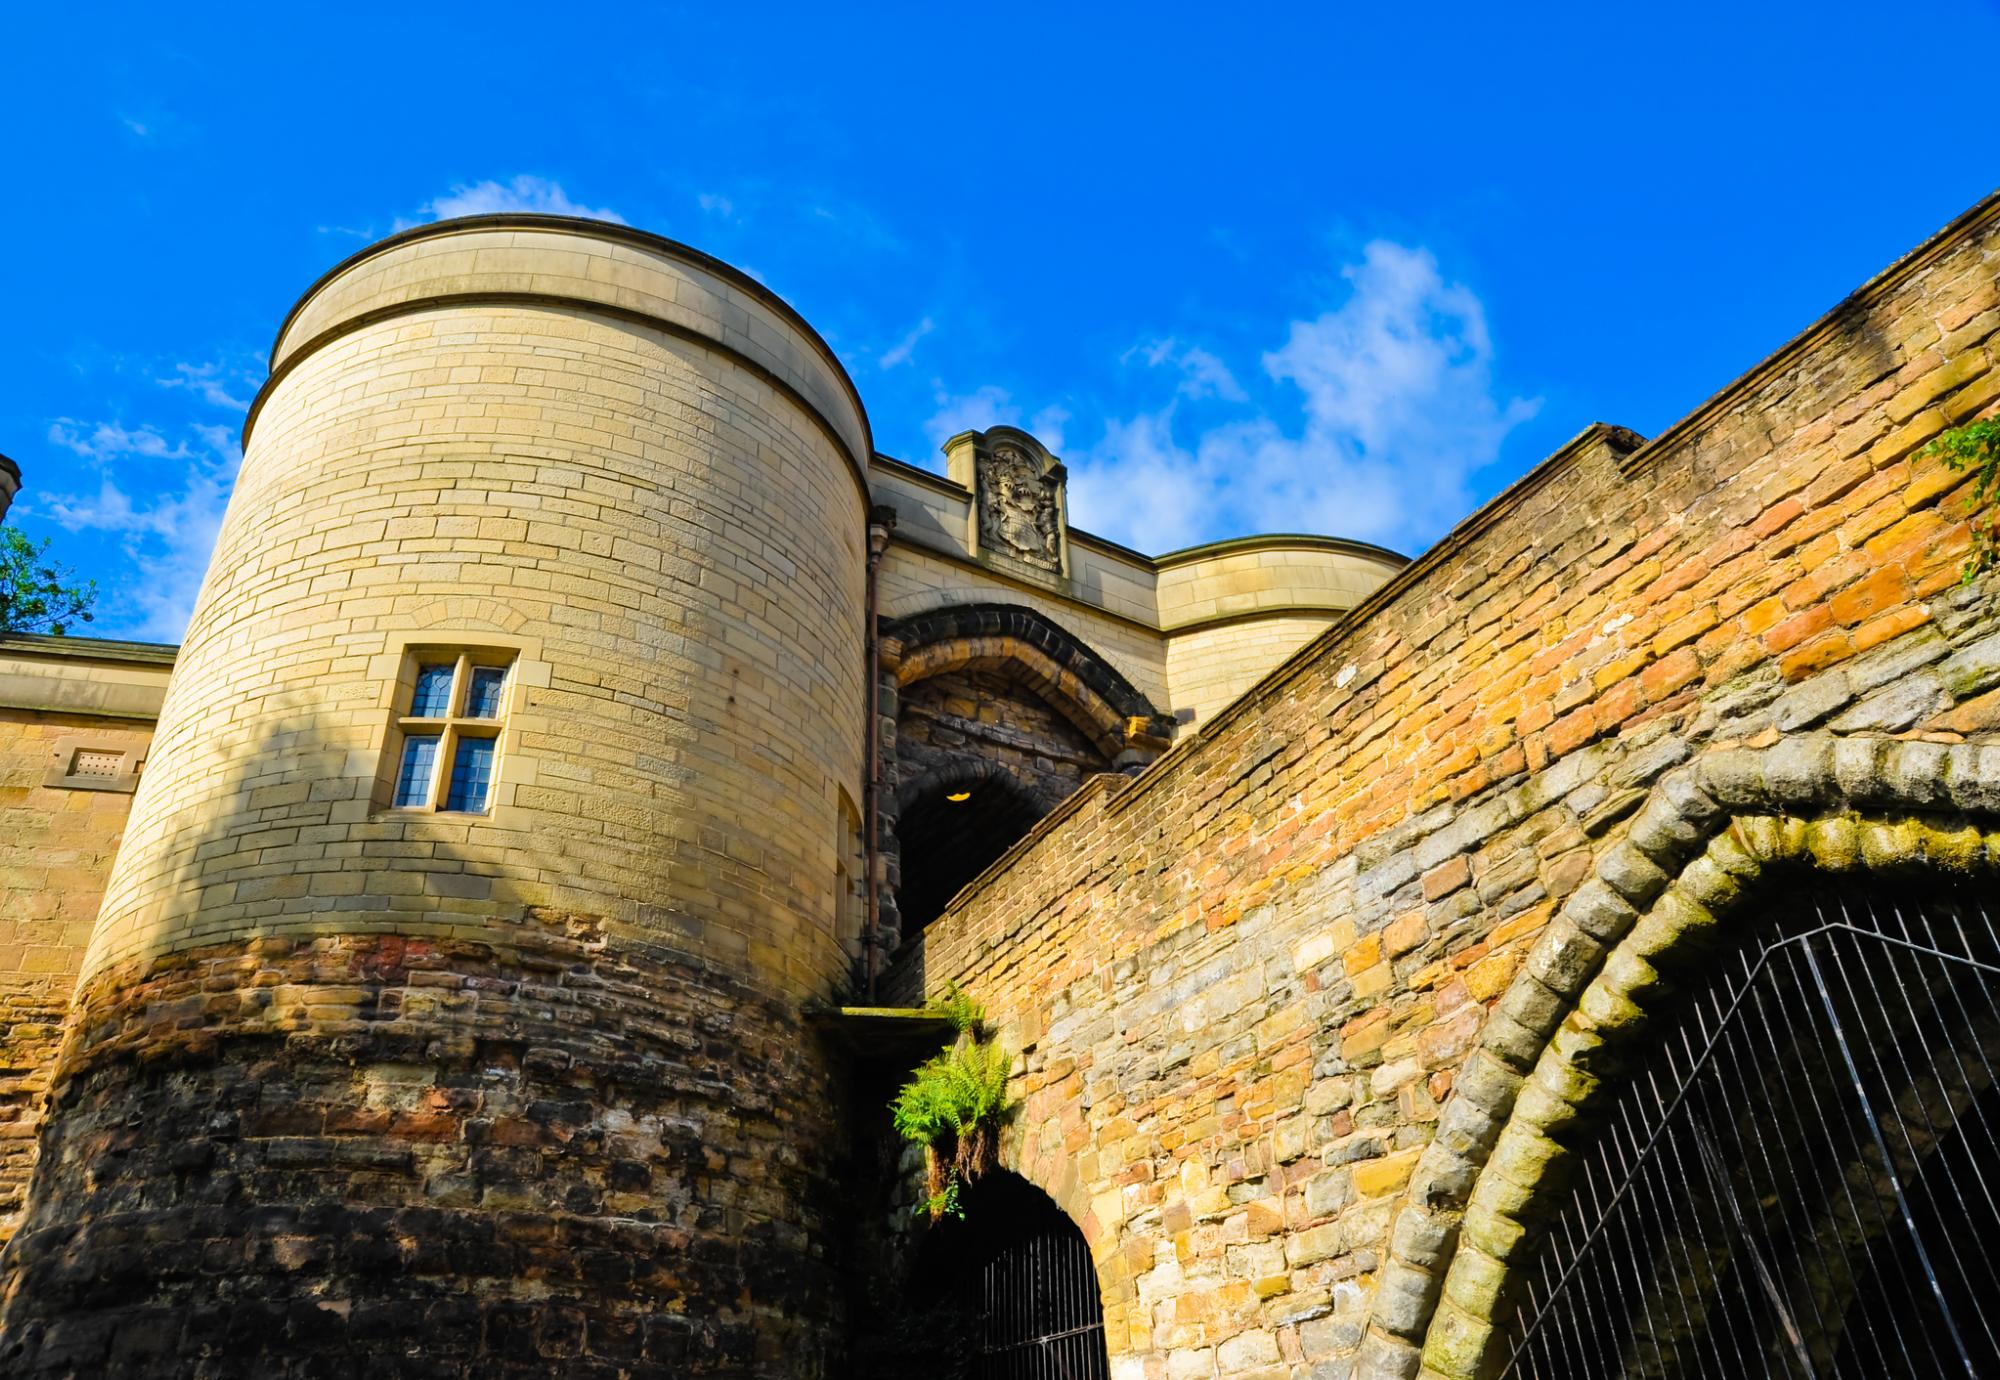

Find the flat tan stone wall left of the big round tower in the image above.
[{"left": 0, "top": 710, "right": 150, "bottom": 1244}]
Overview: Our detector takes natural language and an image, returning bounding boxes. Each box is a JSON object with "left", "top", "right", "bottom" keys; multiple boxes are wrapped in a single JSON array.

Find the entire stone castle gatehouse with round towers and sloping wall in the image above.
[{"left": 0, "top": 200, "right": 2000, "bottom": 1380}]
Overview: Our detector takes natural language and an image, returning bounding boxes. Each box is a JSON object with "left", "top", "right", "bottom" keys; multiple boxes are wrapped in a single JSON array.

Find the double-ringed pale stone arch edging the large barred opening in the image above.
[{"left": 1356, "top": 734, "right": 2000, "bottom": 1380}]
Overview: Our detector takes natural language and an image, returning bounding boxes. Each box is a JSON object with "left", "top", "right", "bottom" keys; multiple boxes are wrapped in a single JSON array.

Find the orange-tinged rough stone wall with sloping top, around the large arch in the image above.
[{"left": 894, "top": 204, "right": 2000, "bottom": 1380}]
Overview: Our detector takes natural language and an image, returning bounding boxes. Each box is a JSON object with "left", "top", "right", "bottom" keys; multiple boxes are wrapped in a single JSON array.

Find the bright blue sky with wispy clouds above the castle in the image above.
[{"left": 0, "top": 0, "right": 2000, "bottom": 640}]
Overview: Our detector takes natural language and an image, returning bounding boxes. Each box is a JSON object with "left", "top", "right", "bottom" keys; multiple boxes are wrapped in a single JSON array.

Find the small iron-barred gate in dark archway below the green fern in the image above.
[{"left": 974, "top": 1218, "right": 1110, "bottom": 1380}]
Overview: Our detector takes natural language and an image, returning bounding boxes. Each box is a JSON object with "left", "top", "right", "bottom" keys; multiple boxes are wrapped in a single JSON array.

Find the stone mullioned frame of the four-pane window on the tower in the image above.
[{"left": 374, "top": 642, "right": 524, "bottom": 820}]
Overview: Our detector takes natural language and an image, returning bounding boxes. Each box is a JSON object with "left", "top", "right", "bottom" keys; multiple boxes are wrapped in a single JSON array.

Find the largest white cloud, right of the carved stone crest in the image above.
[{"left": 1070, "top": 240, "right": 1540, "bottom": 550}]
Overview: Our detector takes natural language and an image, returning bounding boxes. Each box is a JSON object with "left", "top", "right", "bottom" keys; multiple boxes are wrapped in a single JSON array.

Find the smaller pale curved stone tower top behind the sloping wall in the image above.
[{"left": 1154, "top": 536, "right": 1408, "bottom": 722}]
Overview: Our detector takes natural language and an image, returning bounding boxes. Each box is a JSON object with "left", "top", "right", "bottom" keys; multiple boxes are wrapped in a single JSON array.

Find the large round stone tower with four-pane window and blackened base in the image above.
[{"left": 0, "top": 216, "right": 870, "bottom": 1376}]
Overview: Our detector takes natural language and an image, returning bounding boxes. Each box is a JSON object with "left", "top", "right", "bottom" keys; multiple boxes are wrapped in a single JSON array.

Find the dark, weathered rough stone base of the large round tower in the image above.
[{"left": 0, "top": 916, "right": 840, "bottom": 1376}]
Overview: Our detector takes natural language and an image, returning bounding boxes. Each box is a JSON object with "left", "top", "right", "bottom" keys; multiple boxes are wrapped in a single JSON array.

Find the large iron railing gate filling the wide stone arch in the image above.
[{"left": 1504, "top": 888, "right": 2000, "bottom": 1380}]
